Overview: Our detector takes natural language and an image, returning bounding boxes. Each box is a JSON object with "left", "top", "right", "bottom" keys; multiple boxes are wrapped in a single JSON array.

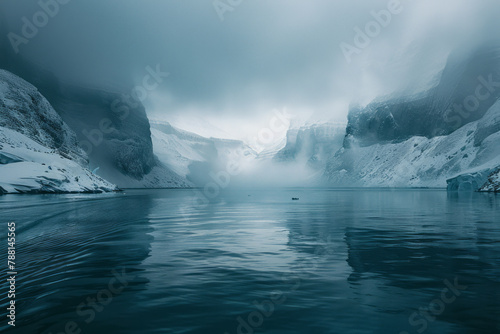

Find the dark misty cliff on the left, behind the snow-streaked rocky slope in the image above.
[{"left": 0, "top": 39, "right": 187, "bottom": 187}]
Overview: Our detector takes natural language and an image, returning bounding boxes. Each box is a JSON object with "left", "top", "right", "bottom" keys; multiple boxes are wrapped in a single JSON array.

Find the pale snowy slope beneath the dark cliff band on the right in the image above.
[{"left": 325, "top": 101, "right": 500, "bottom": 187}]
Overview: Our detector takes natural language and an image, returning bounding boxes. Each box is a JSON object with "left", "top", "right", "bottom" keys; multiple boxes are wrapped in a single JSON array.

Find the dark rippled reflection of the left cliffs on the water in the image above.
[{"left": 0, "top": 190, "right": 152, "bottom": 333}]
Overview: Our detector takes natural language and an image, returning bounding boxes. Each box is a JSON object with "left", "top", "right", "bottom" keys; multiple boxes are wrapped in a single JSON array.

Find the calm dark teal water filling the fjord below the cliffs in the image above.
[{"left": 0, "top": 189, "right": 500, "bottom": 334}]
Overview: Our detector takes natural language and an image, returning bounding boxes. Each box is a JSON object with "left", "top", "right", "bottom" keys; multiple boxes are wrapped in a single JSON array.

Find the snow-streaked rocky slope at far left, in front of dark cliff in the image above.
[{"left": 0, "top": 70, "right": 116, "bottom": 193}]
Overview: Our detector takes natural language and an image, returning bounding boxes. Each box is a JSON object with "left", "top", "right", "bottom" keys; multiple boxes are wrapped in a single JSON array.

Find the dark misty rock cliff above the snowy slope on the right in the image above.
[{"left": 346, "top": 47, "right": 500, "bottom": 146}]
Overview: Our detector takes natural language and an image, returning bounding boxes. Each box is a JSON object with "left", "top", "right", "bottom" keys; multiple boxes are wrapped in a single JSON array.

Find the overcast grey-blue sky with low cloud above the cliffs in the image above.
[{"left": 0, "top": 0, "right": 500, "bottom": 136}]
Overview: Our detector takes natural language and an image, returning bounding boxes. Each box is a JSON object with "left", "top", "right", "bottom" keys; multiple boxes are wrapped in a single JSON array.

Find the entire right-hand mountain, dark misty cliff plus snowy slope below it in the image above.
[{"left": 325, "top": 48, "right": 500, "bottom": 190}]
